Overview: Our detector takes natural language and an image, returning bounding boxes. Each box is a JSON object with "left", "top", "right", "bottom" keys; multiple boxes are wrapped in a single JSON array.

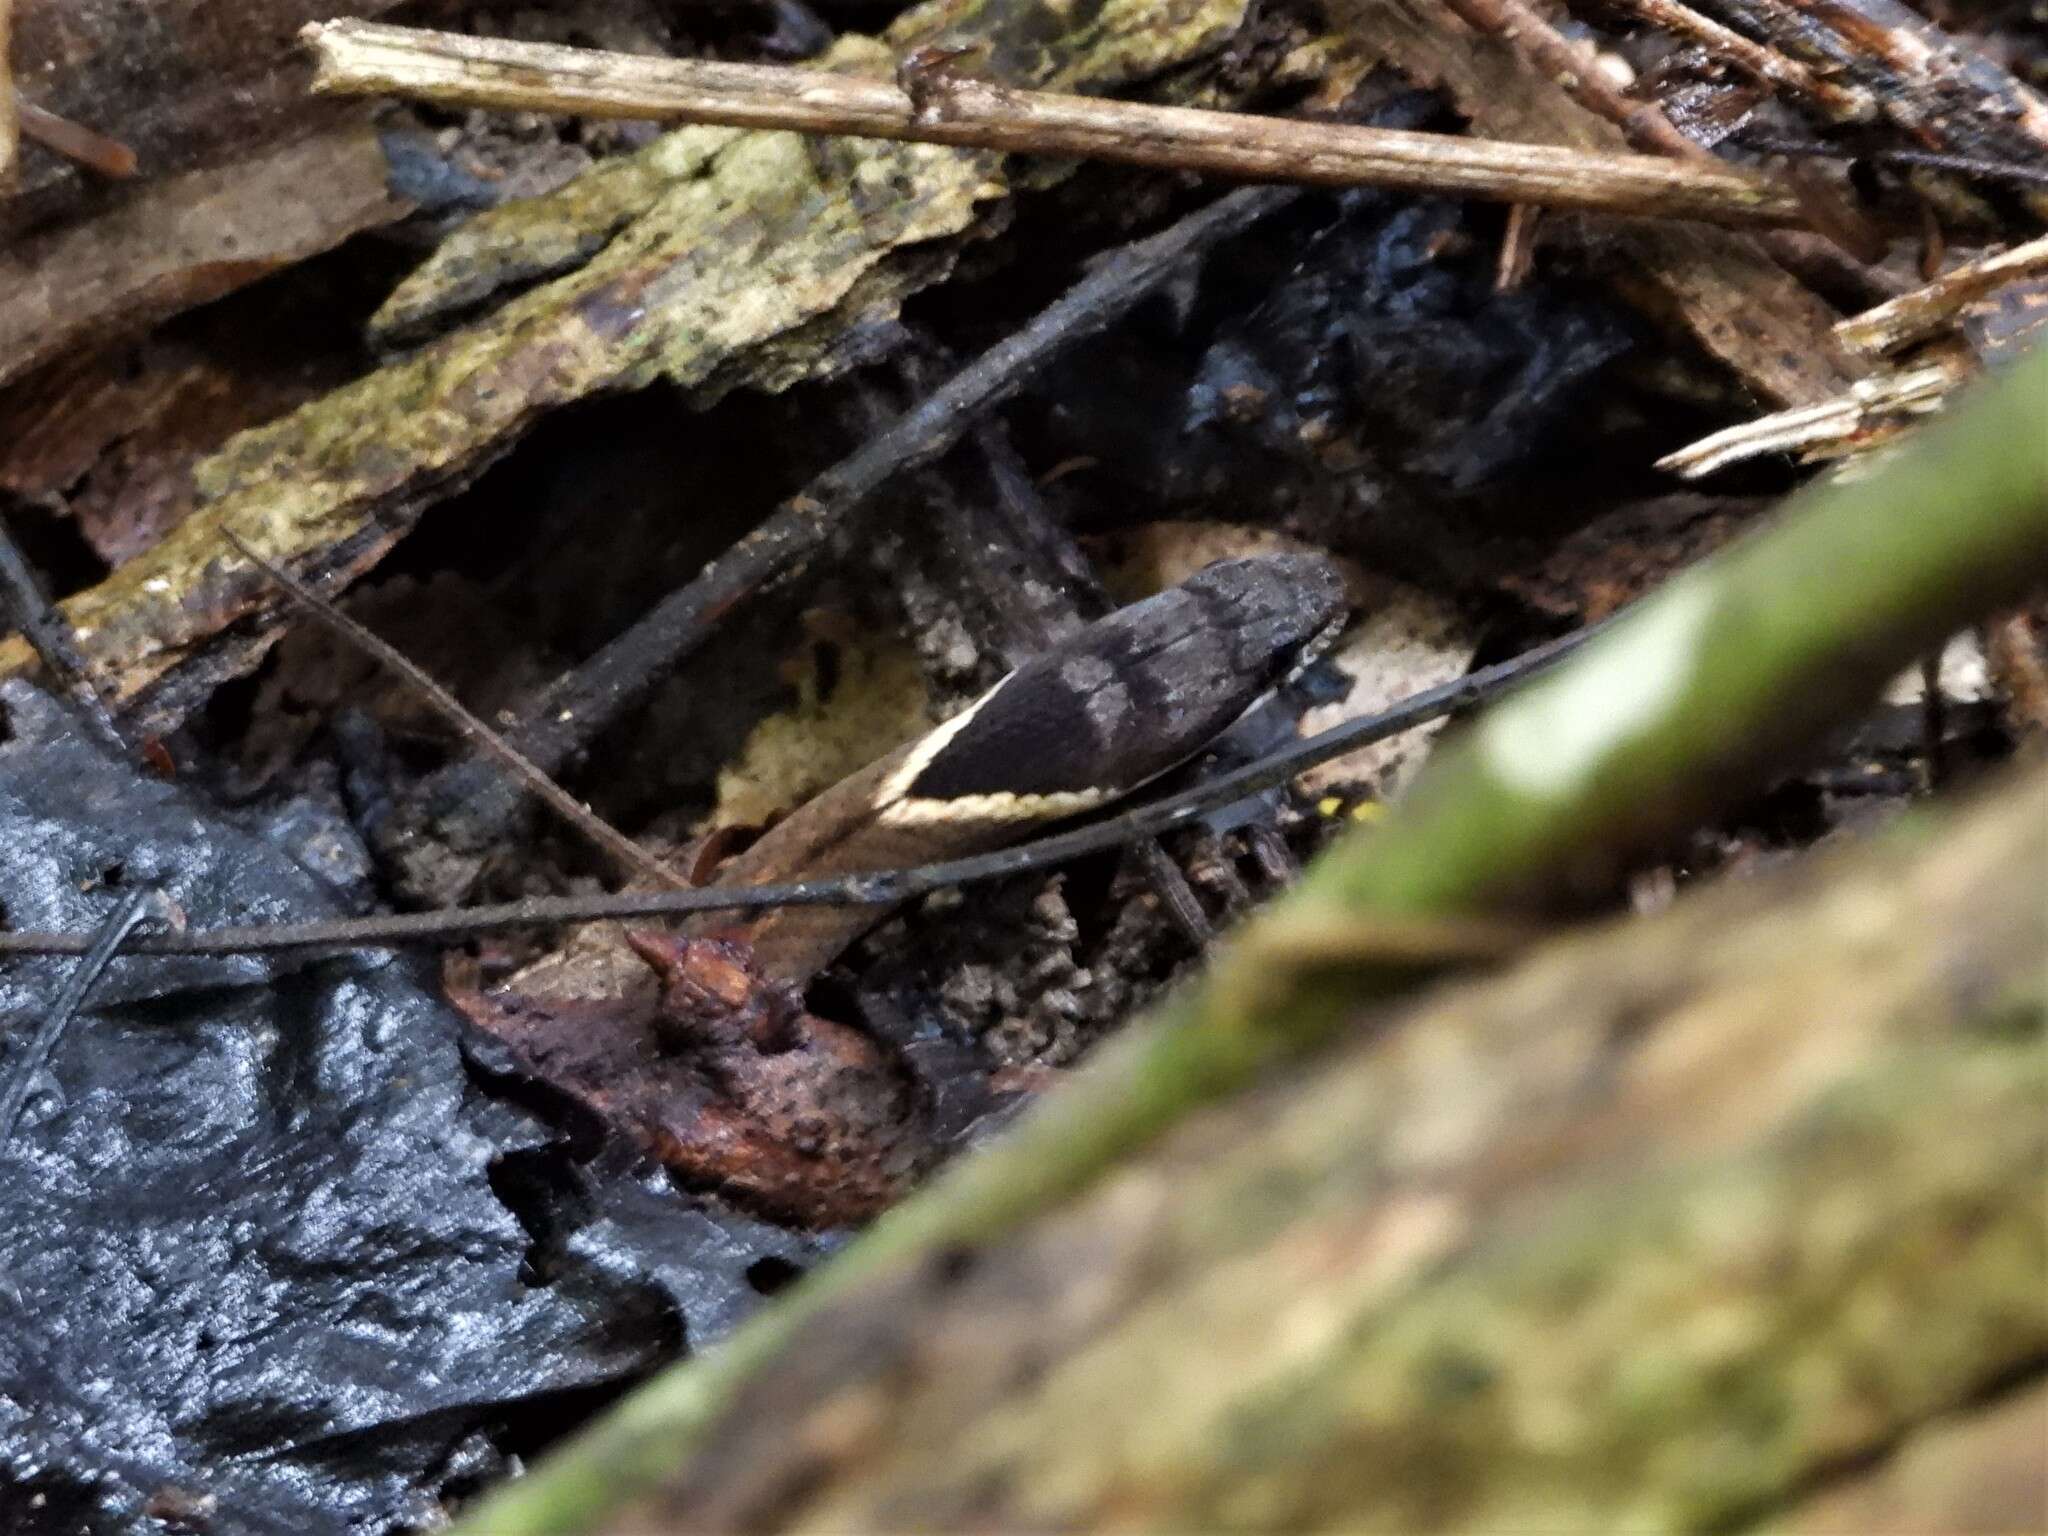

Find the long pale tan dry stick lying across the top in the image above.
[{"left": 301, "top": 20, "right": 1804, "bottom": 225}]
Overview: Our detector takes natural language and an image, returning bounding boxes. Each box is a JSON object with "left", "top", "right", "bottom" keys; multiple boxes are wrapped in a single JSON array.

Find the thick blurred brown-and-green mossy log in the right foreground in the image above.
[{"left": 491, "top": 770, "right": 2048, "bottom": 1534}]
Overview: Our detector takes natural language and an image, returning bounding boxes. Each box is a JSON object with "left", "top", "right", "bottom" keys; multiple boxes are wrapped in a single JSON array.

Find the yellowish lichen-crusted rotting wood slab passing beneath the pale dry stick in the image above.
[{"left": 0, "top": 0, "right": 1243, "bottom": 729}]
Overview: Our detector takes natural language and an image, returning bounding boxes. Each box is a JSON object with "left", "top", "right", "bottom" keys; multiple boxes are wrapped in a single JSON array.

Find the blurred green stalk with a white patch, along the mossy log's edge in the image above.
[{"left": 461, "top": 348, "right": 2048, "bottom": 1536}]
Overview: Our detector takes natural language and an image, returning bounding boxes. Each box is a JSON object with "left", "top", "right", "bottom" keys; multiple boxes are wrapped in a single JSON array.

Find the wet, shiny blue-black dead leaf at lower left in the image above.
[{"left": 0, "top": 684, "right": 829, "bottom": 1532}]
